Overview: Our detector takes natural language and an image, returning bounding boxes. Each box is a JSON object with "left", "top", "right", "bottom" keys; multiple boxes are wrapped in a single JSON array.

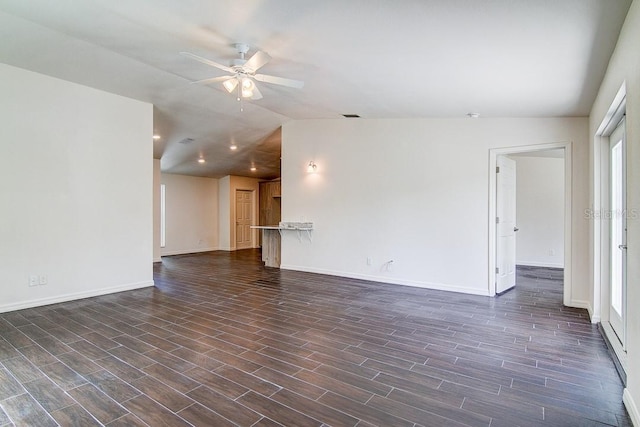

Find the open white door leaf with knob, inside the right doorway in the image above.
[{"left": 496, "top": 156, "right": 517, "bottom": 293}]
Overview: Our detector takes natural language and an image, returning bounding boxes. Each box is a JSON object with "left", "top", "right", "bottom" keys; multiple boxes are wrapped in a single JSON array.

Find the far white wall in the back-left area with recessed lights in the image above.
[{"left": 160, "top": 173, "right": 219, "bottom": 256}]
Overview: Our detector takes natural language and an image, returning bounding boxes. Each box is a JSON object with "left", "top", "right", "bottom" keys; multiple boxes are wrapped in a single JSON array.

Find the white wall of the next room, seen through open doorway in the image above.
[{"left": 512, "top": 155, "right": 564, "bottom": 268}]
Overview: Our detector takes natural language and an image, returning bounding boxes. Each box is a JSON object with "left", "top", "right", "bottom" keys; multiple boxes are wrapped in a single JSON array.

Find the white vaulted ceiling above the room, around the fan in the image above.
[{"left": 0, "top": 0, "right": 631, "bottom": 178}]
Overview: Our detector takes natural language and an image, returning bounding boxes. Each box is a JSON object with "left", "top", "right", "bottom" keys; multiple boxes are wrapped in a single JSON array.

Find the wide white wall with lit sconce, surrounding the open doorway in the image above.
[{"left": 282, "top": 118, "right": 588, "bottom": 305}]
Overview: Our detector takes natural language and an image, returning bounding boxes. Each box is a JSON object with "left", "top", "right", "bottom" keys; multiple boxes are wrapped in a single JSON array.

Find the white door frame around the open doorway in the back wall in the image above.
[{"left": 487, "top": 141, "right": 572, "bottom": 306}]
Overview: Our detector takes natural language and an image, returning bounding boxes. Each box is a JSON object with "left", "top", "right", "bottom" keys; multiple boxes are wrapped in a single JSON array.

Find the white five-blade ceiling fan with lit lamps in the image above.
[{"left": 180, "top": 43, "right": 304, "bottom": 101}]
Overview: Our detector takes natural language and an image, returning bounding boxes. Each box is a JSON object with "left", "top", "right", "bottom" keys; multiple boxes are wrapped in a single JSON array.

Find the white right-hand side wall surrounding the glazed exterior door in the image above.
[{"left": 589, "top": 0, "right": 640, "bottom": 426}]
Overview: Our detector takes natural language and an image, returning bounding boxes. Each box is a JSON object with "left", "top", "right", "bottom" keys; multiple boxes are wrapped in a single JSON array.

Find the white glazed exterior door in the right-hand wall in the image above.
[{"left": 609, "top": 120, "right": 627, "bottom": 348}]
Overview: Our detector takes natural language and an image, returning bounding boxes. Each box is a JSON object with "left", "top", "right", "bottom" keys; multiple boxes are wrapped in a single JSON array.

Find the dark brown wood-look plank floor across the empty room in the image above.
[{"left": 0, "top": 250, "right": 631, "bottom": 427}]
